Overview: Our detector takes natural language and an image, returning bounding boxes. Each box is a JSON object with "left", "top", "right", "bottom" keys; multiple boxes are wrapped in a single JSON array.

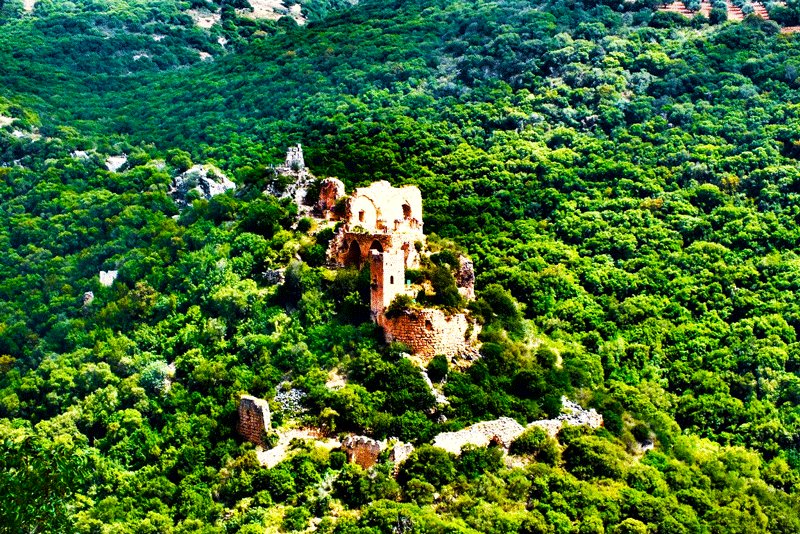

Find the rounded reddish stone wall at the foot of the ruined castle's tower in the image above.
[{"left": 378, "top": 308, "right": 477, "bottom": 358}]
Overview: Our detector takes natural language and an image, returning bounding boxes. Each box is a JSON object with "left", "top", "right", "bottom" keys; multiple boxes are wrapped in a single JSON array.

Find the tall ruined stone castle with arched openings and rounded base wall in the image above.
[{"left": 317, "top": 179, "right": 478, "bottom": 358}]
